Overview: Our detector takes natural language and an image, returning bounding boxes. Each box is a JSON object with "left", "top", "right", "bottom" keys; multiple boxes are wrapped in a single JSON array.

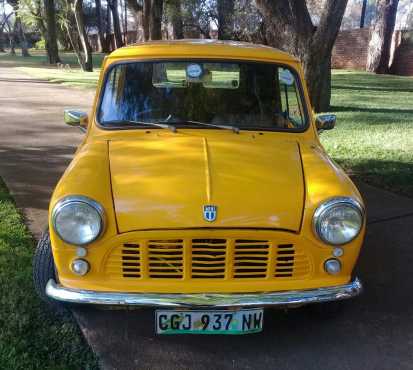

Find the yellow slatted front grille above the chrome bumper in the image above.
[{"left": 105, "top": 238, "right": 311, "bottom": 280}]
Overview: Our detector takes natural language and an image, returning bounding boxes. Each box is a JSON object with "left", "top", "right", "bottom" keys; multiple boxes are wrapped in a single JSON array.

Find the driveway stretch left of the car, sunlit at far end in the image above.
[{"left": 0, "top": 65, "right": 94, "bottom": 236}]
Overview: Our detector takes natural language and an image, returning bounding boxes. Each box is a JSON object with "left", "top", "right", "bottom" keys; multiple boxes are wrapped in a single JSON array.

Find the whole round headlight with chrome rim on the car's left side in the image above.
[{"left": 52, "top": 196, "right": 104, "bottom": 245}]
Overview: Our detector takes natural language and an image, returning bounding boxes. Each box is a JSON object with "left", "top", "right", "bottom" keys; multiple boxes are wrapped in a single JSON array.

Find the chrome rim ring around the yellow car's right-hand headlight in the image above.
[{"left": 313, "top": 197, "right": 365, "bottom": 246}]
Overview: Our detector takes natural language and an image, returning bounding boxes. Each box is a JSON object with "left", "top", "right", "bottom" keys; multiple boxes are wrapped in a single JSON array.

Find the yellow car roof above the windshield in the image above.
[{"left": 109, "top": 39, "right": 298, "bottom": 62}]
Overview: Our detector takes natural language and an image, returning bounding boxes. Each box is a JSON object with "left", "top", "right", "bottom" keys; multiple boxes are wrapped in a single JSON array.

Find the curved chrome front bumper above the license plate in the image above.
[{"left": 46, "top": 278, "right": 362, "bottom": 308}]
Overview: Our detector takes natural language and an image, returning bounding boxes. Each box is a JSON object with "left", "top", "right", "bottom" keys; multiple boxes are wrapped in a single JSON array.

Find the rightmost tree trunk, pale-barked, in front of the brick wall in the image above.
[{"left": 366, "top": 0, "right": 399, "bottom": 73}]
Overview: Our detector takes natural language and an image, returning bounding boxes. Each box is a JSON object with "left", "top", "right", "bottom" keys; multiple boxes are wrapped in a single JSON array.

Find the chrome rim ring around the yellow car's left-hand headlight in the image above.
[{"left": 52, "top": 195, "right": 106, "bottom": 246}]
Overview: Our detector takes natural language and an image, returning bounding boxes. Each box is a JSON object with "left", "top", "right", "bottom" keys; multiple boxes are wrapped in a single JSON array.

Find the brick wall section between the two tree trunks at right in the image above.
[{"left": 331, "top": 28, "right": 370, "bottom": 70}]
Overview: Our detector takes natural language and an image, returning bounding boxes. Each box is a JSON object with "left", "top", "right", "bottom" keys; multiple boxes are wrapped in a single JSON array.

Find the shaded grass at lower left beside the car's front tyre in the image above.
[{"left": 0, "top": 181, "right": 97, "bottom": 370}]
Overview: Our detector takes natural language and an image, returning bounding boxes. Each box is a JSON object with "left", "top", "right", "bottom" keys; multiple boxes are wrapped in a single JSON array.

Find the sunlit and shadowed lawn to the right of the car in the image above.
[{"left": 321, "top": 70, "right": 413, "bottom": 197}]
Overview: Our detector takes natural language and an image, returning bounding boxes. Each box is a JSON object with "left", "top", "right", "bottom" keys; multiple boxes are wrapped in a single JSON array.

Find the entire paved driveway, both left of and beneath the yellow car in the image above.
[{"left": 0, "top": 68, "right": 413, "bottom": 370}]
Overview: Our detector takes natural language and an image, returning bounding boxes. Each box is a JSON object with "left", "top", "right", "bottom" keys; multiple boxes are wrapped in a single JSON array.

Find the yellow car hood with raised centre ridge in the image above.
[{"left": 109, "top": 134, "right": 304, "bottom": 232}]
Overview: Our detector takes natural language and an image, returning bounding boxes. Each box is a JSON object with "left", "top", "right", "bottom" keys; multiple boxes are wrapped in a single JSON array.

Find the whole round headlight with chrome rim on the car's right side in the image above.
[{"left": 313, "top": 197, "right": 364, "bottom": 245}]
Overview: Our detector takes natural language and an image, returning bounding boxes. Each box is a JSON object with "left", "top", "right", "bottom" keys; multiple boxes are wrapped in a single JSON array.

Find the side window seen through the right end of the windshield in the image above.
[{"left": 278, "top": 67, "right": 304, "bottom": 128}]
